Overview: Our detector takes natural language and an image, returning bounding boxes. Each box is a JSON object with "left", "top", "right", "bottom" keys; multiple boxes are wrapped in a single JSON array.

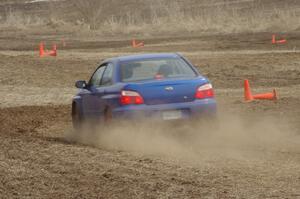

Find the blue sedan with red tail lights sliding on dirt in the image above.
[{"left": 72, "top": 53, "right": 216, "bottom": 128}]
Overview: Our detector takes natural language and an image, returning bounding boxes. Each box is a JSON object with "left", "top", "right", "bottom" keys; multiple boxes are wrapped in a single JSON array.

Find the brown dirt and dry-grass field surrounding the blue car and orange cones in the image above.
[{"left": 0, "top": 0, "right": 300, "bottom": 199}]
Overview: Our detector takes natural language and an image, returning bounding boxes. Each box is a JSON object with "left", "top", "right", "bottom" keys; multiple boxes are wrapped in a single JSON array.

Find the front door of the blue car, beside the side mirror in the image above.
[{"left": 81, "top": 64, "right": 106, "bottom": 117}]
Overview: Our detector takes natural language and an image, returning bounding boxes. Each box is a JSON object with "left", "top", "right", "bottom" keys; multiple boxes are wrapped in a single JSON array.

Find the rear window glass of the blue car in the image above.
[{"left": 121, "top": 58, "right": 197, "bottom": 82}]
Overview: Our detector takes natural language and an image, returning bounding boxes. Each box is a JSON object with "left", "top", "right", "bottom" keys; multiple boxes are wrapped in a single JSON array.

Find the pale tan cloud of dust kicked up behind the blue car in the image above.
[{"left": 68, "top": 114, "right": 300, "bottom": 161}]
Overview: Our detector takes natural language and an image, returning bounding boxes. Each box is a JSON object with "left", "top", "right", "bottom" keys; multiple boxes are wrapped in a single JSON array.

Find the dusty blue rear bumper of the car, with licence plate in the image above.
[{"left": 112, "top": 98, "right": 217, "bottom": 120}]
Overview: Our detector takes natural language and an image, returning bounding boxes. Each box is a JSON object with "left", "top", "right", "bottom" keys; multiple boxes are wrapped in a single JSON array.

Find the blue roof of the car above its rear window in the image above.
[{"left": 105, "top": 53, "right": 180, "bottom": 62}]
